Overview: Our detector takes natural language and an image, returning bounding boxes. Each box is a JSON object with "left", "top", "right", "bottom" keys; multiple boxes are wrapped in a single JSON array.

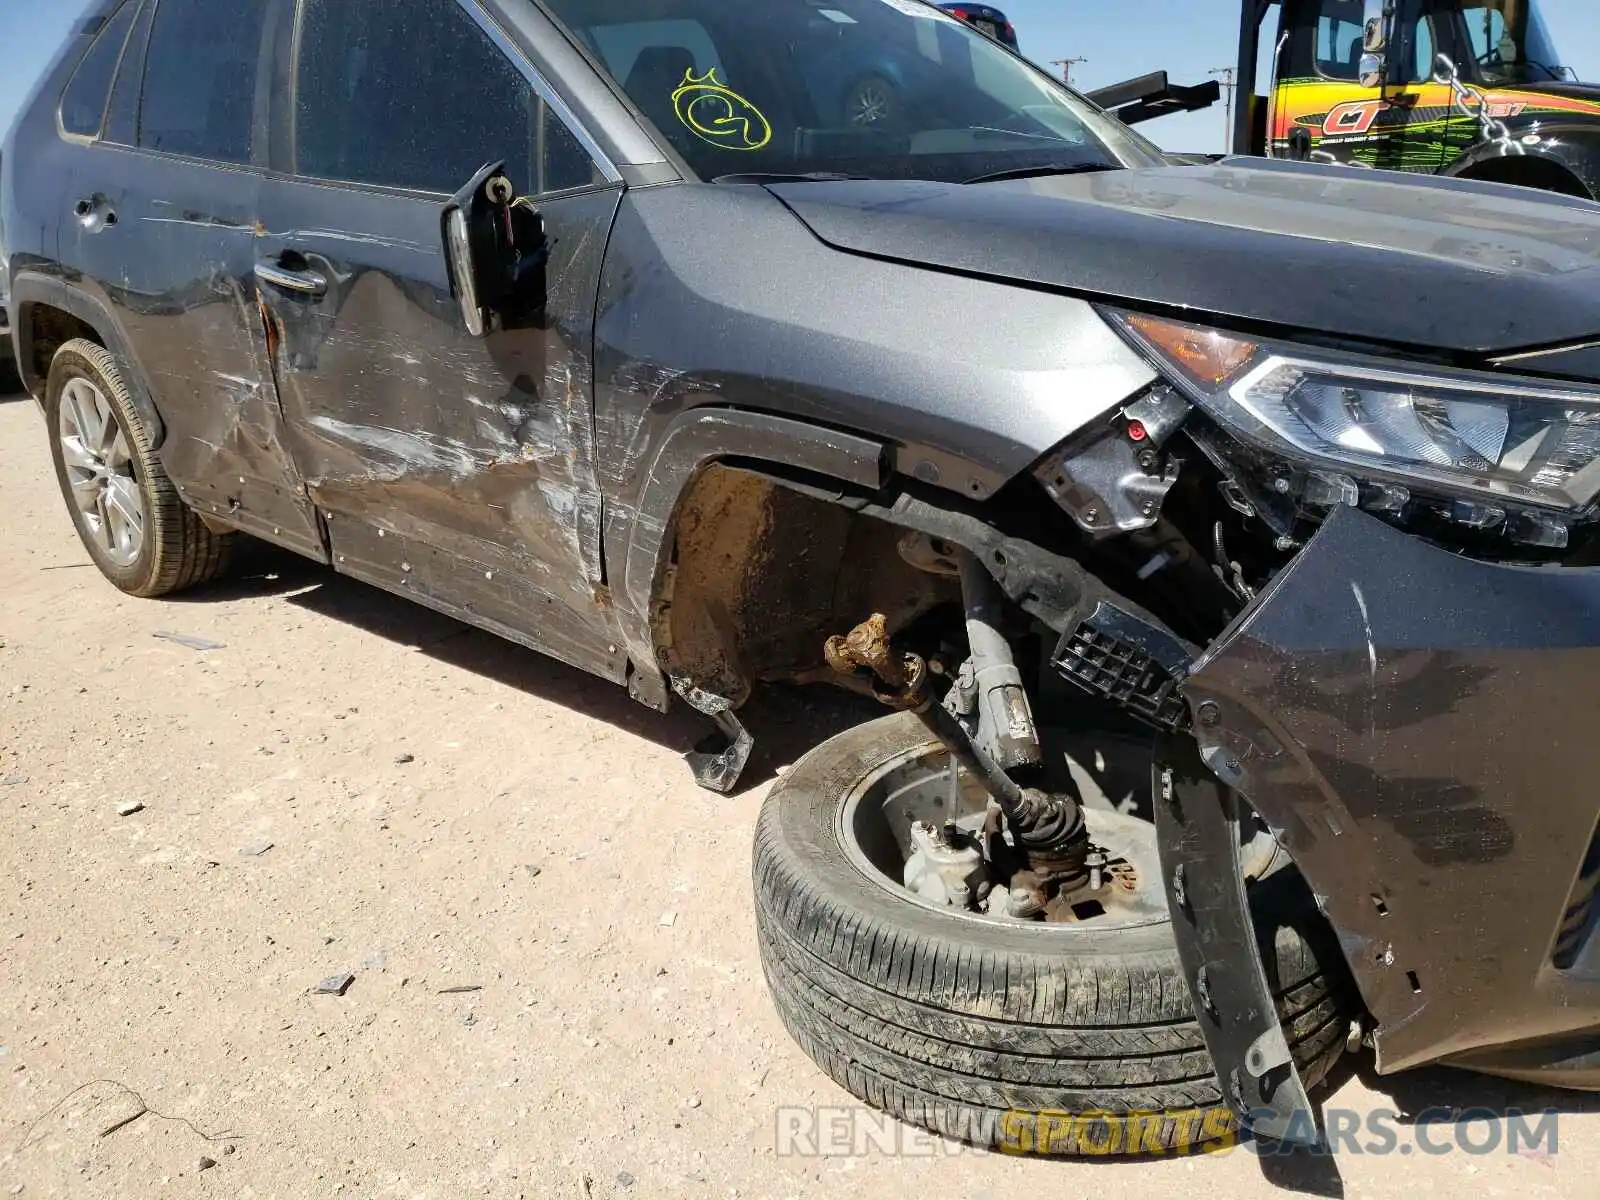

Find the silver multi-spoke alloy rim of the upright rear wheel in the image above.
[{"left": 59, "top": 379, "right": 144, "bottom": 566}]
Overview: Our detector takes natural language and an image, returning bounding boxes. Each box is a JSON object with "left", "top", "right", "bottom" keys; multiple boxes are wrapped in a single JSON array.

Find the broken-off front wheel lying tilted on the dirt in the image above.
[{"left": 755, "top": 714, "right": 1354, "bottom": 1155}]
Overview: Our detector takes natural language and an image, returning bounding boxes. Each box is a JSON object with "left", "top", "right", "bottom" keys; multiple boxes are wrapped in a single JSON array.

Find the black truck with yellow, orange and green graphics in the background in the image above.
[{"left": 1234, "top": 0, "right": 1600, "bottom": 200}]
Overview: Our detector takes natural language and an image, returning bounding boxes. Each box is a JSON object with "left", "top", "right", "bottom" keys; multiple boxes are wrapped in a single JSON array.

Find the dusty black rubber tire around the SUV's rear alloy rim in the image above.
[{"left": 46, "top": 338, "right": 235, "bottom": 598}]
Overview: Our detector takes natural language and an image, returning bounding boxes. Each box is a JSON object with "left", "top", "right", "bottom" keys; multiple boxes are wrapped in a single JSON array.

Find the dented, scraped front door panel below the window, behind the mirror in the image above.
[{"left": 256, "top": 182, "right": 626, "bottom": 678}]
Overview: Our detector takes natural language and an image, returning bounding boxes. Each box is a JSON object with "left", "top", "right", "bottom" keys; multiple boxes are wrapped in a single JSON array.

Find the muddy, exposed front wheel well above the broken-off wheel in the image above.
[{"left": 650, "top": 464, "right": 1237, "bottom": 712}]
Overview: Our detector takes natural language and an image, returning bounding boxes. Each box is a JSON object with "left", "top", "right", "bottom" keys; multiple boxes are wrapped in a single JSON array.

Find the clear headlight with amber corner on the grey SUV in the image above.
[{"left": 1107, "top": 312, "right": 1600, "bottom": 512}]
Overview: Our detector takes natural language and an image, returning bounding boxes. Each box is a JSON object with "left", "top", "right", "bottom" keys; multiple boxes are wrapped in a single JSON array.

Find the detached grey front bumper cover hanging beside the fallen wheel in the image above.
[{"left": 1163, "top": 509, "right": 1600, "bottom": 1115}]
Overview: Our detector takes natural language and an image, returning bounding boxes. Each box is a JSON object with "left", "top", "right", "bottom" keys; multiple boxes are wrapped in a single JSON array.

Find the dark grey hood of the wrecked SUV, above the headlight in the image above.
[{"left": 770, "top": 158, "right": 1600, "bottom": 355}]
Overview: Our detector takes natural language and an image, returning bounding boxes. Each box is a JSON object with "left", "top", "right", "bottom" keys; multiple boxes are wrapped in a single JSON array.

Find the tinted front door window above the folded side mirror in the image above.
[{"left": 294, "top": 0, "right": 595, "bottom": 194}]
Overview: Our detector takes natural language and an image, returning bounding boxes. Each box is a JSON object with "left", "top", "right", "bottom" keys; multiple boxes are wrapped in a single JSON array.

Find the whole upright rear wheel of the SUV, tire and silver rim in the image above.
[{"left": 45, "top": 339, "right": 232, "bottom": 597}]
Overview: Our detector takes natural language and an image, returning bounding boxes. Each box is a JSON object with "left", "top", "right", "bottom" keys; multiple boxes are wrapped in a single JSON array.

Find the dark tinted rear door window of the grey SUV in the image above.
[{"left": 139, "top": 0, "right": 267, "bottom": 163}]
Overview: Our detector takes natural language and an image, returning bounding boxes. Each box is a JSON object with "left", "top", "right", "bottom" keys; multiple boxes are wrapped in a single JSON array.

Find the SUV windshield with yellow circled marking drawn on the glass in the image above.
[{"left": 546, "top": 0, "right": 1160, "bottom": 182}]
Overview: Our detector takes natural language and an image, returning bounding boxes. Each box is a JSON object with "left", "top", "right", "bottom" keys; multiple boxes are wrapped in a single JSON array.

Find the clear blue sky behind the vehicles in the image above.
[{"left": 0, "top": 0, "right": 1600, "bottom": 154}]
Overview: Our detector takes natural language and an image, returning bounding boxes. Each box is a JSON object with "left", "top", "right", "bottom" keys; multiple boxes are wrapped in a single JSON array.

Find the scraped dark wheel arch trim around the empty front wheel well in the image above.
[{"left": 608, "top": 408, "right": 888, "bottom": 715}]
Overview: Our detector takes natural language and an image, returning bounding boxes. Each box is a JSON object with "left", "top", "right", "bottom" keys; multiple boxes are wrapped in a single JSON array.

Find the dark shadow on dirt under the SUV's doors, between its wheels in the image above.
[{"left": 171, "top": 542, "right": 883, "bottom": 794}]
